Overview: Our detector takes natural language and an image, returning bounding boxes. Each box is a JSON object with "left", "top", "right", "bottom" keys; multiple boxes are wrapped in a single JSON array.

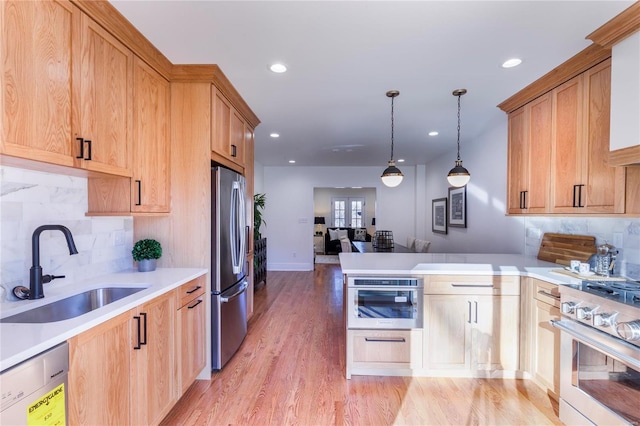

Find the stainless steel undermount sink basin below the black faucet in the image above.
[{"left": 0, "top": 287, "right": 147, "bottom": 323}]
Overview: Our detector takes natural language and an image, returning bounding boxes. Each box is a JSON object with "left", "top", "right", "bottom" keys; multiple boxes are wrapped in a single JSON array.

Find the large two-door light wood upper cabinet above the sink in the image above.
[{"left": 0, "top": 0, "right": 133, "bottom": 176}]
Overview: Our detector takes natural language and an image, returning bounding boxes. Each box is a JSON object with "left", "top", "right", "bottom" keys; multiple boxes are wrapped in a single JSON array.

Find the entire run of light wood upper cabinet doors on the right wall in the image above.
[{"left": 507, "top": 59, "right": 639, "bottom": 214}]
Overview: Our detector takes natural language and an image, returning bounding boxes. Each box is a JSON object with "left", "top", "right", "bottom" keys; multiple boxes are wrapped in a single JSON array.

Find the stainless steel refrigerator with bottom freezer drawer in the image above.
[{"left": 211, "top": 166, "right": 249, "bottom": 370}]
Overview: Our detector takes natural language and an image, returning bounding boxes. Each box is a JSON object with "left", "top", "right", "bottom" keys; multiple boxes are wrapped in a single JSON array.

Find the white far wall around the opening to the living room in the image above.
[{"left": 263, "top": 164, "right": 416, "bottom": 270}]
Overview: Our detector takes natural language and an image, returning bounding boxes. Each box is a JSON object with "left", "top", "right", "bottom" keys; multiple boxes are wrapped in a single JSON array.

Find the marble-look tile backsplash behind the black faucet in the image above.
[{"left": 0, "top": 166, "right": 133, "bottom": 302}]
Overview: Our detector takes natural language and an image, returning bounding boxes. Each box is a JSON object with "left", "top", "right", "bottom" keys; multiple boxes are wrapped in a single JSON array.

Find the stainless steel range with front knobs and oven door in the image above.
[{"left": 552, "top": 281, "right": 640, "bottom": 425}]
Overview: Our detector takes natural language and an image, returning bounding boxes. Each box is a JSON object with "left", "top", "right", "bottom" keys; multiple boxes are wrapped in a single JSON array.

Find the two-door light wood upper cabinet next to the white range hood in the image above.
[{"left": 551, "top": 60, "right": 625, "bottom": 213}]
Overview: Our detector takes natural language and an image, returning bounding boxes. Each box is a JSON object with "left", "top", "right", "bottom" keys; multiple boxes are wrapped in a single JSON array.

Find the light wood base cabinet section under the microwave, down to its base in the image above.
[{"left": 347, "top": 329, "right": 422, "bottom": 378}]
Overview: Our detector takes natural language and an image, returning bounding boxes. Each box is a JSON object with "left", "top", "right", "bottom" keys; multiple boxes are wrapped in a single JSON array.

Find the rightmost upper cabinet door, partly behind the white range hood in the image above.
[{"left": 582, "top": 60, "right": 625, "bottom": 213}]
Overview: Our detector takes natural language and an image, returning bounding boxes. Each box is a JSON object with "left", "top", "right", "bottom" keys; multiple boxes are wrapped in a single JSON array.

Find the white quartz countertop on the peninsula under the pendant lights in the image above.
[{"left": 340, "top": 253, "right": 586, "bottom": 284}]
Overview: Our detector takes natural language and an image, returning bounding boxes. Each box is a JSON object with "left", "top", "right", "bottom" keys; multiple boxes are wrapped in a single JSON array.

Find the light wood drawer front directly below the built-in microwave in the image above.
[{"left": 349, "top": 330, "right": 422, "bottom": 364}]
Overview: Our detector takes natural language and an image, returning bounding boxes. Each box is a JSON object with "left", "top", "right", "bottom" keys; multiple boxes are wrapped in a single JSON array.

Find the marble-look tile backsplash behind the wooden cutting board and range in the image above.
[{"left": 524, "top": 216, "right": 640, "bottom": 280}]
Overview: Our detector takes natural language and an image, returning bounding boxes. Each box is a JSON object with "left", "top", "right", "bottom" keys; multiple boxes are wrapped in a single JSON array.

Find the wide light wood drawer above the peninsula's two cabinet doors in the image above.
[{"left": 424, "top": 275, "right": 520, "bottom": 296}]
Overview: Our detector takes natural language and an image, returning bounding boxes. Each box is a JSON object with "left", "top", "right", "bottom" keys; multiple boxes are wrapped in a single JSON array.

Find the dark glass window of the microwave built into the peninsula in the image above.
[{"left": 356, "top": 290, "right": 416, "bottom": 319}]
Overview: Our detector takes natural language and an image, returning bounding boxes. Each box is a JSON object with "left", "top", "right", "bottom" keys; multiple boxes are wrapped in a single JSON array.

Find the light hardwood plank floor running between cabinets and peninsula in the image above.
[{"left": 163, "top": 265, "right": 561, "bottom": 425}]
